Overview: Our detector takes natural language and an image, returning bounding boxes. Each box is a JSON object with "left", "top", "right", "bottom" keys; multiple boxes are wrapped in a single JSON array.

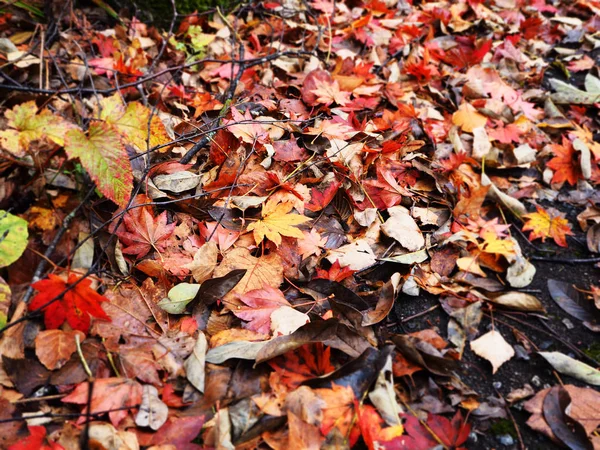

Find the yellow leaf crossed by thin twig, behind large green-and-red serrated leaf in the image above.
[{"left": 97, "top": 94, "right": 171, "bottom": 152}]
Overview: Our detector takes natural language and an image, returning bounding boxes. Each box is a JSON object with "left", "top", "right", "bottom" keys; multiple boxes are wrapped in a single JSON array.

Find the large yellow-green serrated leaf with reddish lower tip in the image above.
[{"left": 65, "top": 122, "right": 133, "bottom": 208}]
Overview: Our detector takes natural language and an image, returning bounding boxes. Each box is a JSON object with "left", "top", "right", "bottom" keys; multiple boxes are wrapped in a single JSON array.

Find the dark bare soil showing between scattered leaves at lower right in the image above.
[{"left": 395, "top": 236, "right": 600, "bottom": 450}]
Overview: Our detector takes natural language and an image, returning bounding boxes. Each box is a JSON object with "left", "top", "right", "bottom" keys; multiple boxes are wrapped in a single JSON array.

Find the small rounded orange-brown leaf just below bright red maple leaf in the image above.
[{"left": 35, "top": 330, "right": 85, "bottom": 370}]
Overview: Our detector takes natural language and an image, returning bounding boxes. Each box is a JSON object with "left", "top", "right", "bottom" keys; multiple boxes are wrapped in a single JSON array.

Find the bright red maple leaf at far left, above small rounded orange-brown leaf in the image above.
[{"left": 29, "top": 274, "right": 110, "bottom": 333}]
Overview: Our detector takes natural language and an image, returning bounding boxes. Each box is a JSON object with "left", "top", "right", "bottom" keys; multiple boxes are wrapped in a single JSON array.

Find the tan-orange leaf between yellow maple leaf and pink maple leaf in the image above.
[{"left": 213, "top": 247, "right": 283, "bottom": 301}]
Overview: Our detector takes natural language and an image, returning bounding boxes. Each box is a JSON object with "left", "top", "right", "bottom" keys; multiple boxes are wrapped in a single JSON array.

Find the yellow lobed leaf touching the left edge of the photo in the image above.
[{"left": 0, "top": 101, "right": 75, "bottom": 157}]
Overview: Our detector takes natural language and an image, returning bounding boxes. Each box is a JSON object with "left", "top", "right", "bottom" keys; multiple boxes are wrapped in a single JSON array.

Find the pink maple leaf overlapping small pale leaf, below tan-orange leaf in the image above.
[{"left": 232, "top": 285, "right": 291, "bottom": 334}]
